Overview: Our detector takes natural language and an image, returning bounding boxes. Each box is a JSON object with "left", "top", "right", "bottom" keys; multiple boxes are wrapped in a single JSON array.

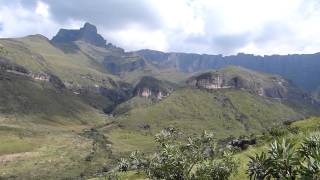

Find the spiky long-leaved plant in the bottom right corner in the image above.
[{"left": 247, "top": 136, "right": 320, "bottom": 180}]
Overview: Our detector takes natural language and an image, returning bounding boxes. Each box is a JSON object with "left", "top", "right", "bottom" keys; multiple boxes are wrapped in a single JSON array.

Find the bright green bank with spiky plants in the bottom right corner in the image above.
[{"left": 237, "top": 118, "right": 320, "bottom": 179}]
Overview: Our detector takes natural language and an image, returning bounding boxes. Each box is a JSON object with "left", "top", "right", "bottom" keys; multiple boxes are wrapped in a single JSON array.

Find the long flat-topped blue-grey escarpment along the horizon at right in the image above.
[{"left": 136, "top": 50, "right": 320, "bottom": 92}]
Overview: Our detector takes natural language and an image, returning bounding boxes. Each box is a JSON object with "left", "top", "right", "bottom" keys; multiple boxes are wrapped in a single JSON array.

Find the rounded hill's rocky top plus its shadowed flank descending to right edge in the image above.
[{"left": 187, "top": 66, "right": 320, "bottom": 114}]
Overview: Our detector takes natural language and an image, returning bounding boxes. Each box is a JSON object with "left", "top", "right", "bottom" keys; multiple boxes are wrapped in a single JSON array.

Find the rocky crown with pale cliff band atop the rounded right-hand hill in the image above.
[{"left": 187, "top": 67, "right": 305, "bottom": 99}]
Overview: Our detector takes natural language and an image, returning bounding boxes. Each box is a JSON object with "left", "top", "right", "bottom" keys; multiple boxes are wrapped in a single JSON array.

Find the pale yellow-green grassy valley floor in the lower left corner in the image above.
[{"left": 0, "top": 122, "right": 112, "bottom": 179}]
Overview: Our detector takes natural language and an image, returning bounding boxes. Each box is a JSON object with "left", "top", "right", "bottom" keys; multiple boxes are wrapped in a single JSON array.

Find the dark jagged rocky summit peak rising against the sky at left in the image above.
[{"left": 51, "top": 22, "right": 107, "bottom": 47}]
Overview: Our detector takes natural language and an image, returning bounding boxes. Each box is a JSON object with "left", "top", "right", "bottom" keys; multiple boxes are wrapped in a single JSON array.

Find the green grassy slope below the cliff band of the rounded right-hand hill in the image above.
[{"left": 114, "top": 89, "right": 296, "bottom": 138}]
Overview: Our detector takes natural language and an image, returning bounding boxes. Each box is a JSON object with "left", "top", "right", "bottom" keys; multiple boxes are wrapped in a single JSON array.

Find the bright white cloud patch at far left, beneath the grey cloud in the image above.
[{"left": 0, "top": 1, "right": 82, "bottom": 38}]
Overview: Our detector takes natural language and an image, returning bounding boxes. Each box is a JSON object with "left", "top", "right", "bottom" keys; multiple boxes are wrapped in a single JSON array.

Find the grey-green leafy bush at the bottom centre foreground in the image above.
[{"left": 120, "top": 128, "right": 237, "bottom": 180}]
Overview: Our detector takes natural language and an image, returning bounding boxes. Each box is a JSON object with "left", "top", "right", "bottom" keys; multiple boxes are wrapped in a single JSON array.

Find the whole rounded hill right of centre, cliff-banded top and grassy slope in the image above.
[{"left": 112, "top": 66, "right": 320, "bottom": 137}]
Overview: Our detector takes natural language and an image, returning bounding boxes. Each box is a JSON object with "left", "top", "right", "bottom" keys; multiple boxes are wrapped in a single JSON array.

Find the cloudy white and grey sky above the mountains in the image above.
[{"left": 0, "top": 0, "right": 320, "bottom": 55}]
